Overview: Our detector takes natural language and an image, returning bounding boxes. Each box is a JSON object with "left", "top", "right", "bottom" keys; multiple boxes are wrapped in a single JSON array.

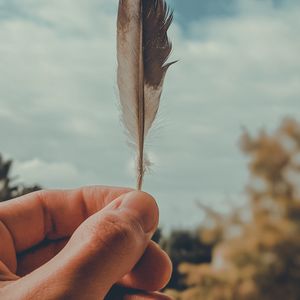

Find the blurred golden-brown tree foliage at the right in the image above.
[{"left": 169, "top": 119, "right": 300, "bottom": 300}]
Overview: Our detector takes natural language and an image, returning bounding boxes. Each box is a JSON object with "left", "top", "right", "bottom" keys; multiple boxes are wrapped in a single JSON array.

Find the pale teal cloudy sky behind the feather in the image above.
[{"left": 0, "top": 0, "right": 300, "bottom": 228}]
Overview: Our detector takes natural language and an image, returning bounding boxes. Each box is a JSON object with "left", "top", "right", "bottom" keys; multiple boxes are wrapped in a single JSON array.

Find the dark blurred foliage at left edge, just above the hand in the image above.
[{"left": 0, "top": 154, "right": 41, "bottom": 202}]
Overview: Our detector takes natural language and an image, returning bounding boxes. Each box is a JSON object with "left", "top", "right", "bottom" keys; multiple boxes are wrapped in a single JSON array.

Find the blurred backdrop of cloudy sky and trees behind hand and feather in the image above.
[{"left": 0, "top": 0, "right": 300, "bottom": 300}]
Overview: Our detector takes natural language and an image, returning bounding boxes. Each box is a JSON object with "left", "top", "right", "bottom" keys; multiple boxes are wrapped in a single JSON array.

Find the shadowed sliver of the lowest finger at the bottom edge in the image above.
[{"left": 105, "top": 286, "right": 172, "bottom": 300}]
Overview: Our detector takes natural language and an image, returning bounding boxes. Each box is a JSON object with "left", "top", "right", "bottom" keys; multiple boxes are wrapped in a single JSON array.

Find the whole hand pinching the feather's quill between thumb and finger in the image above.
[{"left": 0, "top": 187, "right": 171, "bottom": 300}]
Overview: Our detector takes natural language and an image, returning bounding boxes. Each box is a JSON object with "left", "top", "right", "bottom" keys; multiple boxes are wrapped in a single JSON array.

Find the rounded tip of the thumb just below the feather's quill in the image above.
[{"left": 120, "top": 191, "right": 158, "bottom": 234}]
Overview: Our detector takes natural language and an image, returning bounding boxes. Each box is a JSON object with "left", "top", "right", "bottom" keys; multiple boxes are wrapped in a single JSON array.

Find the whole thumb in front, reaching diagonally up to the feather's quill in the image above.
[{"left": 4, "top": 192, "right": 158, "bottom": 300}]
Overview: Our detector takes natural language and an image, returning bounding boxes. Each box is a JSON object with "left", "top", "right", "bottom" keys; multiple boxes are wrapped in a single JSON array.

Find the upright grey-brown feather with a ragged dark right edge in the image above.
[{"left": 117, "top": 0, "right": 174, "bottom": 190}]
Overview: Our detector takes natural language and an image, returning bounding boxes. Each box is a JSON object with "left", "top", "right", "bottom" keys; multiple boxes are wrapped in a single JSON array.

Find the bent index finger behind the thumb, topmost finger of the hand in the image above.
[{"left": 0, "top": 186, "right": 130, "bottom": 254}]
